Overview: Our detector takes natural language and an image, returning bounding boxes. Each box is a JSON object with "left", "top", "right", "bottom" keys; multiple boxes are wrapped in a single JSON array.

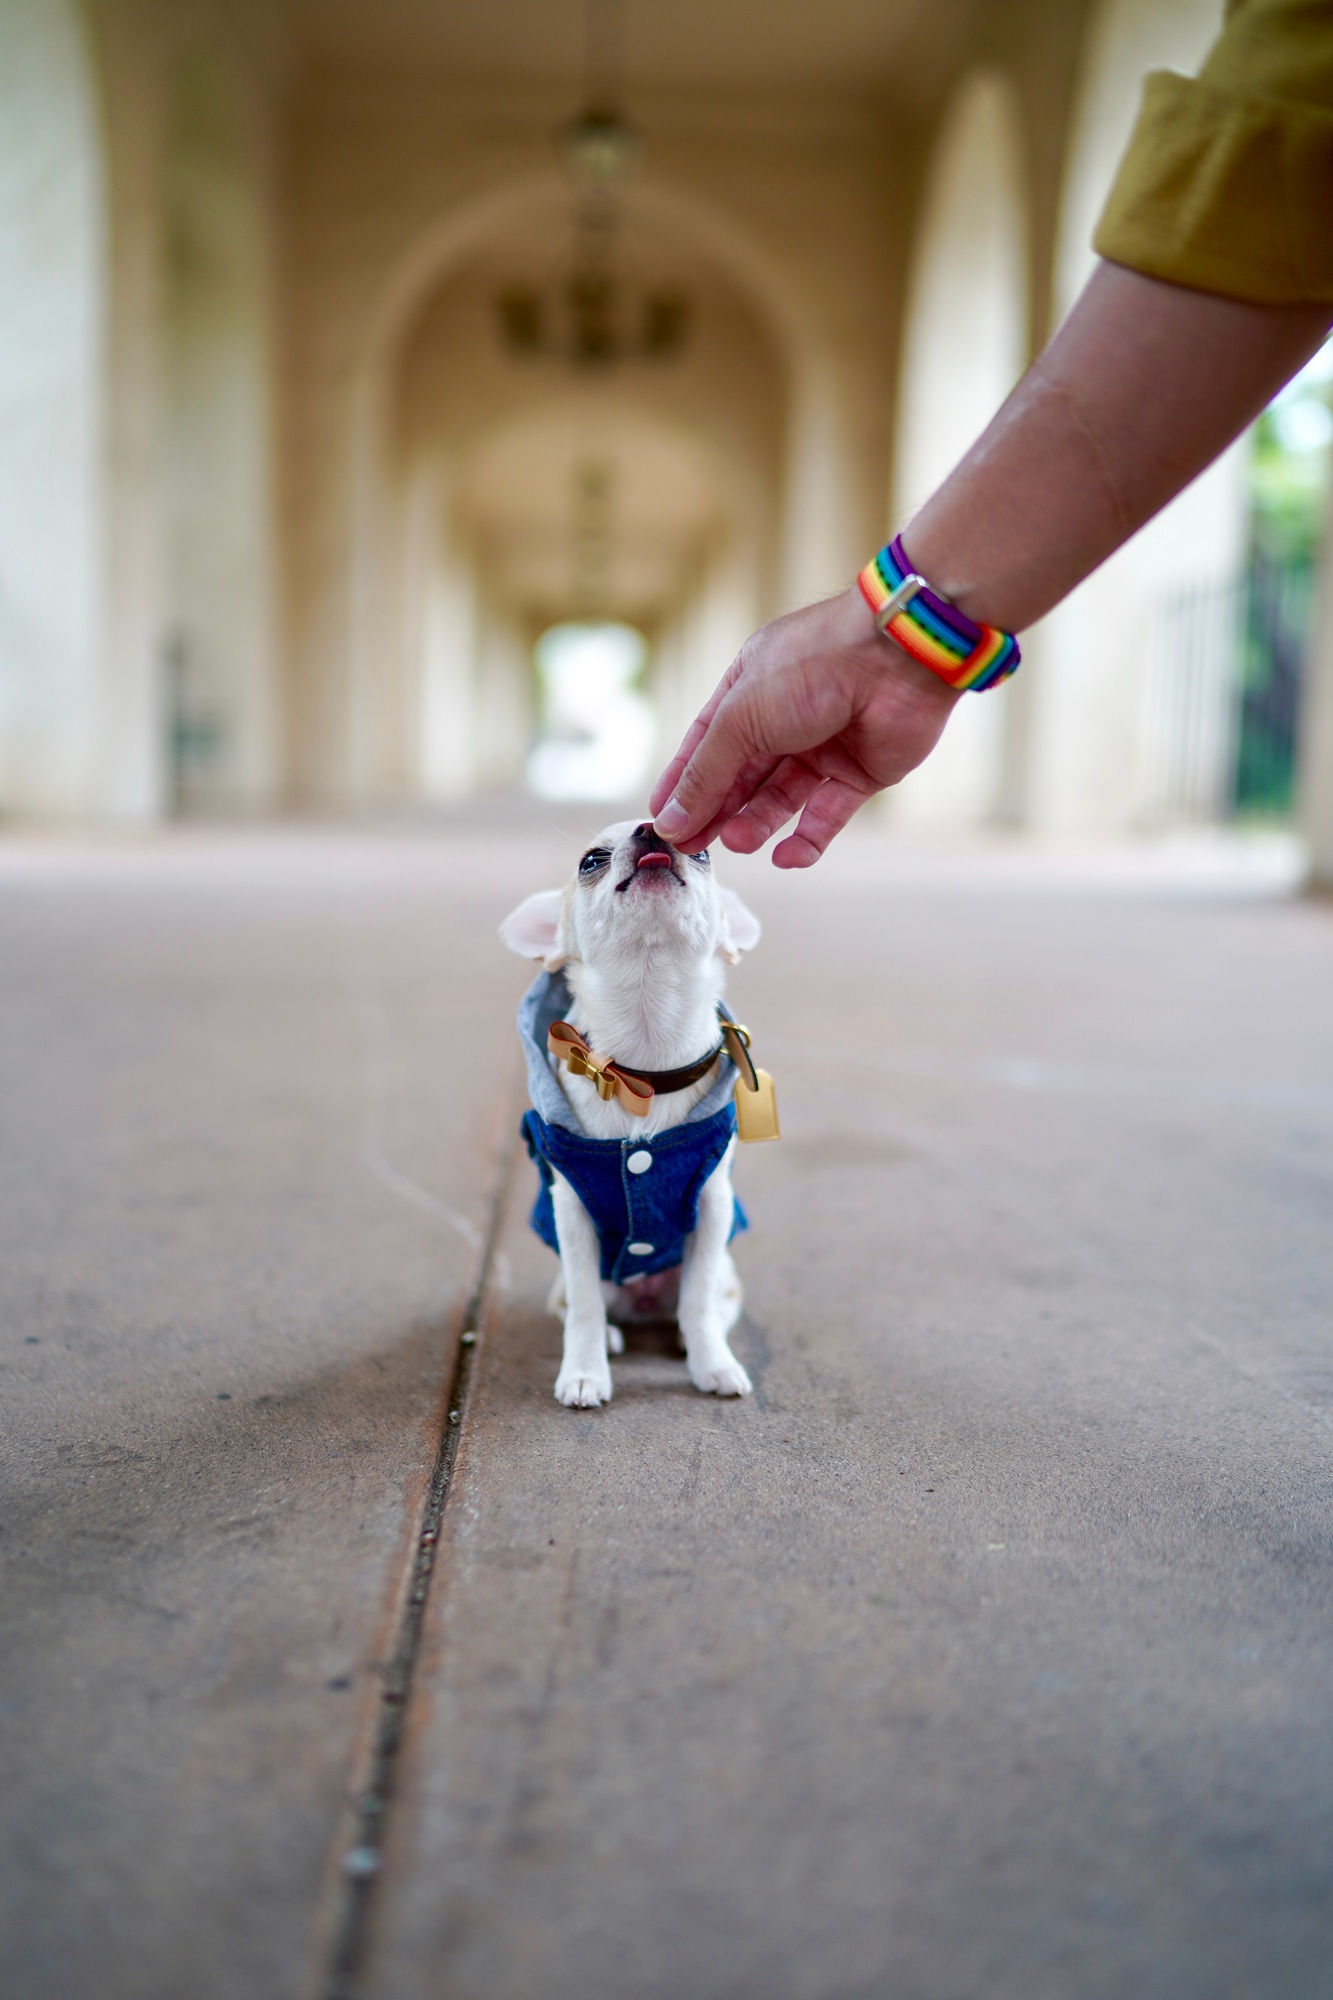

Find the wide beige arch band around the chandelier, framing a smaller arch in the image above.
[{"left": 326, "top": 178, "right": 816, "bottom": 798}]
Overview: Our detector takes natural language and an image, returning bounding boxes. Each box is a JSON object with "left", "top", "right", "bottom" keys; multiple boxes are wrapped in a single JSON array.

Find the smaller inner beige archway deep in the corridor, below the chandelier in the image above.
[{"left": 402, "top": 386, "right": 765, "bottom": 798}]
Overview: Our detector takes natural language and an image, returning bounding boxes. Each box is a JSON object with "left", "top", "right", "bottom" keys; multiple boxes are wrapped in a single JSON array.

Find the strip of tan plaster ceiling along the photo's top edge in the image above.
[{"left": 288, "top": 0, "right": 956, "bottom": 96}]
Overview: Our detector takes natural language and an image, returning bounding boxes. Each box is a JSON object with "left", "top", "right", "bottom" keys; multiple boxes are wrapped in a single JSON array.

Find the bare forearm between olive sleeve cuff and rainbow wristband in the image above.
[{"left": 903, "top": 264, "right": 1329, "bottom": 632}]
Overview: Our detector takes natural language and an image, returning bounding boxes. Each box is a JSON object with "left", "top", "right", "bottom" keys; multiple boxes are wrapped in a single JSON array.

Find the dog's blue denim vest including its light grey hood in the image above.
[{"left": 518, "top": 972, "right": 749, "bottom": 1284}]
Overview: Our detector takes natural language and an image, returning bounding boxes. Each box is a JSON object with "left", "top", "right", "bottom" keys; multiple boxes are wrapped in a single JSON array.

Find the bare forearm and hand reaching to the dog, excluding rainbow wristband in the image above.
[{"left": 652, "top": 264, "right": 1329, "bottom": 868}]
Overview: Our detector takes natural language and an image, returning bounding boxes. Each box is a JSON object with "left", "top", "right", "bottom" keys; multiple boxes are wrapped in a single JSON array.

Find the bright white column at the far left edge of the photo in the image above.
[{"left": 0, "top": 0, "right": 106, "bottom": 816}]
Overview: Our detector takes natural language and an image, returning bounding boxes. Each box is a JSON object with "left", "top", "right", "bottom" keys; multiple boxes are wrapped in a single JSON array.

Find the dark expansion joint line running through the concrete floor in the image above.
[{"left": 314, "top": 1118, "right": 516, "bottom": 2000}]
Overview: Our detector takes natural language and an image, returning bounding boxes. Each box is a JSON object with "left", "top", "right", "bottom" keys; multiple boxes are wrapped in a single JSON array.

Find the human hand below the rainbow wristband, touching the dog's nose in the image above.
[{"left": 650, "top": 584, "right": 959, "bottom": 868}]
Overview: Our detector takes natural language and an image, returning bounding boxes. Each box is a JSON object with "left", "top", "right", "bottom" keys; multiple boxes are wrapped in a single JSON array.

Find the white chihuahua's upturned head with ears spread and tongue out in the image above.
[{"left": 500, "top": 820, "right": 759, "bottom": 972}]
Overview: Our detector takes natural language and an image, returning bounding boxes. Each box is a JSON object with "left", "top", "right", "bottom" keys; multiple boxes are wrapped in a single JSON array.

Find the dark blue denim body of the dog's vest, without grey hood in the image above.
[{"left": 522, "top": 1104, "right": 749, "bottom": 1284}]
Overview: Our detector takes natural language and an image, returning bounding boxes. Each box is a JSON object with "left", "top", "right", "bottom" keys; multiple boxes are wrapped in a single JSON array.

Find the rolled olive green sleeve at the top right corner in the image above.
[{"left": 1093, "top": 0, "right": 1333, "bottom": 306}]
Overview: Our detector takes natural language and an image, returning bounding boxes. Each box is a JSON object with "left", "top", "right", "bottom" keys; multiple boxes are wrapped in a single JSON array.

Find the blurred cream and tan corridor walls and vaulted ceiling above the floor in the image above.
[{"left": 0, "top": 0, "right": 1327, "bottom": 852}]
